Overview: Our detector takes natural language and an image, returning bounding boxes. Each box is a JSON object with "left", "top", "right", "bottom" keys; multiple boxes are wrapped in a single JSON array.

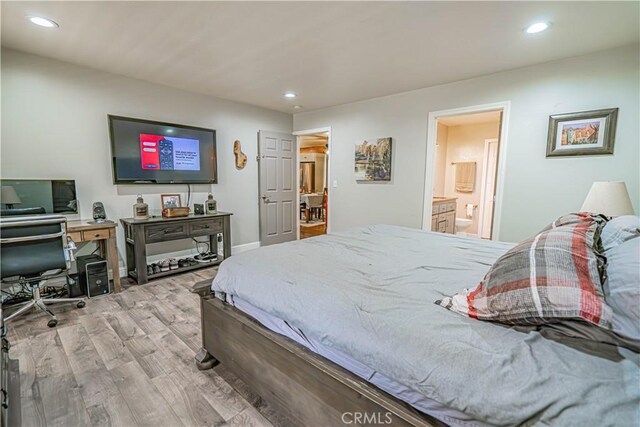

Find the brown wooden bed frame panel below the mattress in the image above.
[{"left": 192, "top": 280, "right": 444, "bottom": 427}]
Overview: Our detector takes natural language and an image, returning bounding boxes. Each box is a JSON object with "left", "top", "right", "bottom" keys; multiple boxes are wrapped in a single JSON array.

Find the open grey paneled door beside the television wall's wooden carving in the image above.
[{"left": 258, "top": 131, "right": 298, "bottom": 246}]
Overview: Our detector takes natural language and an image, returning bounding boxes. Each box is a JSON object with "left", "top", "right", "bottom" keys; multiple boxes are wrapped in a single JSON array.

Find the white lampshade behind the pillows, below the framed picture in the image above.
[{"left": 580, "top": 181, "right": 634, "bottom": 216}]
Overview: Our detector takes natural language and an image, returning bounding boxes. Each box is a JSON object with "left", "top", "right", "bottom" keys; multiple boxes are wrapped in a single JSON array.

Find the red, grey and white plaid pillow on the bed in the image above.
[{"left": 436, "top": 213, "right": 612, "bottom": 329}]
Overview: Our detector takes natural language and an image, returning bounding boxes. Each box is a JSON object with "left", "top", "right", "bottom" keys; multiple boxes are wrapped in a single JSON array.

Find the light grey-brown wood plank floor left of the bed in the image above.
[{"left": 8, "top": 269, "right": 293, "bottom": 427}]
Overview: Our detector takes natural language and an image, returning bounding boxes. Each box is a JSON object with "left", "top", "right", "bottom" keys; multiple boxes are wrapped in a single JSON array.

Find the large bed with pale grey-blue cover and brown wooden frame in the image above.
[{"left": 198, "top": 225, "right": 640, "bottom": 426}]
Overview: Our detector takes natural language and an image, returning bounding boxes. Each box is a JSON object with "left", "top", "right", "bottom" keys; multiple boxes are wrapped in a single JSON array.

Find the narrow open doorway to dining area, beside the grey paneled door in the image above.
[{"left": 298, "top": 131, "right": 329, "bottom": 239}]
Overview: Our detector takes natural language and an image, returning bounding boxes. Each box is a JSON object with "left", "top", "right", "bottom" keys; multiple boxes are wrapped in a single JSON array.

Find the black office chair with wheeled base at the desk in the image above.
[{"left": 0, "top": 215, "right": 85, "bottom": 327}]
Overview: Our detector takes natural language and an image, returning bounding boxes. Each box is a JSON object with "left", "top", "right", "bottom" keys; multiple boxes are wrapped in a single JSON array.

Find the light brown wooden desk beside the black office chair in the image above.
[{"left": 67, "top": 220, "right": 120, "bottom": 292}]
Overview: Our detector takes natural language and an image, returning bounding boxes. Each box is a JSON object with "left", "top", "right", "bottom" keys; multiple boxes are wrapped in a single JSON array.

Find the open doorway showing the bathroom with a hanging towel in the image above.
[{"left": 423, "top": 103, "right": 508, "bottom": 240}]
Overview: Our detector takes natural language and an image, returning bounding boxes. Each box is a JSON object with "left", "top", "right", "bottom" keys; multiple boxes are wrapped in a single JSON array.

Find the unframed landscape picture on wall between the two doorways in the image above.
[{"left": 355, "top": 138, "right": 391, "bottom": 182}]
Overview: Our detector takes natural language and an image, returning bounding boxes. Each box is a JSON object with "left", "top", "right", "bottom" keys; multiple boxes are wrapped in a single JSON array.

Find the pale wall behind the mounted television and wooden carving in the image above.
[{"left": 1, "top": 49, "right": 292, "bottom": 266}]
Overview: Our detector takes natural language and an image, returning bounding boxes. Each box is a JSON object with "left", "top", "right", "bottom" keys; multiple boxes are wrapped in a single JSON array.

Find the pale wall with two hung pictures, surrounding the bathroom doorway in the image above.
[{"left": 294, "top": 45, "right": 640, "bottom": 241}]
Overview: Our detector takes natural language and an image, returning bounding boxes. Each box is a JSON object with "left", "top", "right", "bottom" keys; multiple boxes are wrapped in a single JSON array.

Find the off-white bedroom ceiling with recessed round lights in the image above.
[{"left": 1, "top": 1, "right": 640, "bottom": 113}]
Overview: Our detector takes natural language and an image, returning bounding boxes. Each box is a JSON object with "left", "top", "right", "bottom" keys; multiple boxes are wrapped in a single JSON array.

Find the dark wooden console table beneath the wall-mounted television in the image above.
[{"left": 120, "top": 212, "right": 233, "bottom": 285}]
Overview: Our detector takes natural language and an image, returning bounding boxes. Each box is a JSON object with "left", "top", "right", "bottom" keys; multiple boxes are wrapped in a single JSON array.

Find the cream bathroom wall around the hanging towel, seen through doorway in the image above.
[{"left": 438, "top": 122, "right": 500, "bottom": 234}]
